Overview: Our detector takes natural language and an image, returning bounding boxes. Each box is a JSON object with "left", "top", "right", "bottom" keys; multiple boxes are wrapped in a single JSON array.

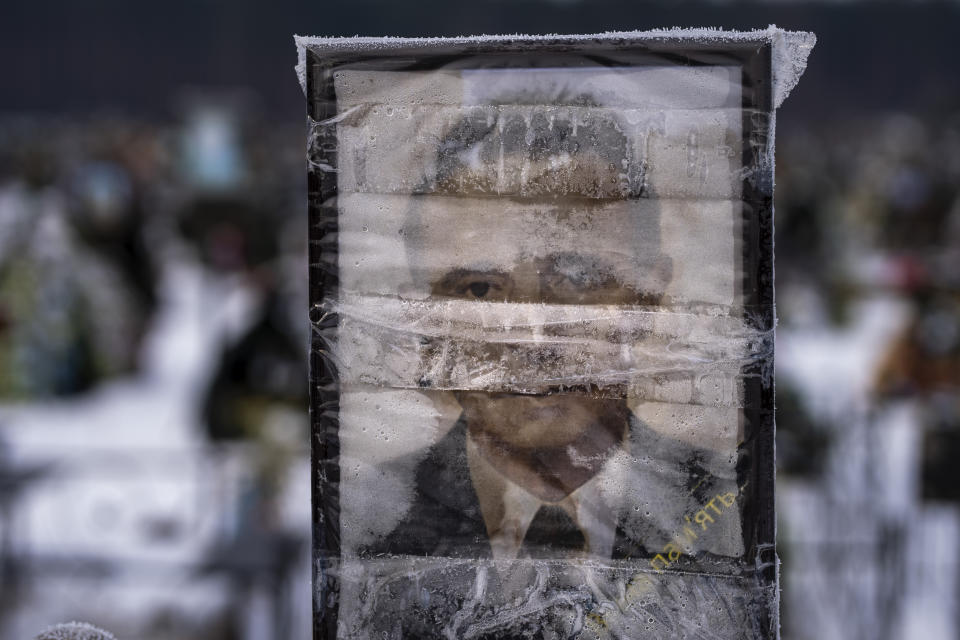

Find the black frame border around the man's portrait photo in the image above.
[{"left": 306, "top": 34, "right": 779, "bottom": 640}]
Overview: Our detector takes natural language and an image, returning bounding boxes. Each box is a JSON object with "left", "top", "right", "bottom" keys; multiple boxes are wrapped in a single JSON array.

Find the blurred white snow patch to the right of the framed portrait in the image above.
[{"left": 777, "top": 295, "right": 960, "bottom": 640}]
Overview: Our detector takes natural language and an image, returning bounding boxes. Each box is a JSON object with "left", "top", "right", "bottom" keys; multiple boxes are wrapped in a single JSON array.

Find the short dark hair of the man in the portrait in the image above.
[{"left": 402, "top": 81, "right": 670, "bottom": 299}]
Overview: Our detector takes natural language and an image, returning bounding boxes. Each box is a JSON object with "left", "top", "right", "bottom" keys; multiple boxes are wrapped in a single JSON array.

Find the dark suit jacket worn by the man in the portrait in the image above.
[{"left": 339, "top": 412, "right": 773, "bottom": 640}]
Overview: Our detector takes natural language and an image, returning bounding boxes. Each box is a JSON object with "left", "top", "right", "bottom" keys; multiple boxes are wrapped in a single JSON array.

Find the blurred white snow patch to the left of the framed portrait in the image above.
[{"left": 0, "top": 262, "right": 309, "bottom": 640}]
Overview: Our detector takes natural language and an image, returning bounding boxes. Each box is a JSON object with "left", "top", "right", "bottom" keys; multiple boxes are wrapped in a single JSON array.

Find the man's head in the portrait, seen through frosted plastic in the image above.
[{"left": 402, "top": 102, "right": 670, "bottom": 499}]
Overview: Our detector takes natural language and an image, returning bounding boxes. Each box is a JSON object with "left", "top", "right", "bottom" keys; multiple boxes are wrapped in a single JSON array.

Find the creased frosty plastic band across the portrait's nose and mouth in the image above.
[{"left": 317, "top": 295, "right": 773, "bottom": 405}]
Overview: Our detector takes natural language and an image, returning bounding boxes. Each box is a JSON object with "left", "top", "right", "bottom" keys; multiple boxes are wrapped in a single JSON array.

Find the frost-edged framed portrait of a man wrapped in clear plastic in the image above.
[{"left": 297, "top": 27, "right": 814, "bottom": 640}]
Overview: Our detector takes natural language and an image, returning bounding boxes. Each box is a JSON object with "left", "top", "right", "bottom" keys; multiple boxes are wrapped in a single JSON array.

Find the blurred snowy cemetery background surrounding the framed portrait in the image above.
[{"left": 0, "top": 0, "right": 960, "bottom": 640}]
